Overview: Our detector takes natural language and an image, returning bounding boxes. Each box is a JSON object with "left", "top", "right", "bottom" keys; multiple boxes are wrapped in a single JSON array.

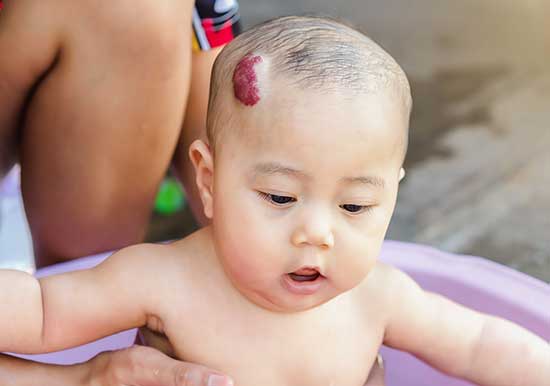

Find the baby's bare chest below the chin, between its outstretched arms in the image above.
[{"left": 160, "top": 294, "right": 383, "bottom": 386}]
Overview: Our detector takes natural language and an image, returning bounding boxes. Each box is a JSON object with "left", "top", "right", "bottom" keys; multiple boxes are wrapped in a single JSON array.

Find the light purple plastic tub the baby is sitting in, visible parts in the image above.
[{"left": 18, "top": 241, "right": 550, "bottom": 386}]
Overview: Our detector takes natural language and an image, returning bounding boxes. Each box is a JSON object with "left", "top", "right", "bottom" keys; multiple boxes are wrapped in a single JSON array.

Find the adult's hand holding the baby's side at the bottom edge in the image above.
[{"left": 86, "top": 346, "right": 233, "bottom": 386}]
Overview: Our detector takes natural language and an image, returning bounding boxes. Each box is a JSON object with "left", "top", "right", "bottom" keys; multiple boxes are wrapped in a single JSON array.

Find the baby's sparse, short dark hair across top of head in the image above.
[{"left": 207, "top": 16, "right": 412, "bottom": 154}]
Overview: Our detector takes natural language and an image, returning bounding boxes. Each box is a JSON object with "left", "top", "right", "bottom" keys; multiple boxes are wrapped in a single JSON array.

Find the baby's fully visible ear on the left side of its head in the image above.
[{"left": 189, "top": 139, "right": 214, "bottom": 219}]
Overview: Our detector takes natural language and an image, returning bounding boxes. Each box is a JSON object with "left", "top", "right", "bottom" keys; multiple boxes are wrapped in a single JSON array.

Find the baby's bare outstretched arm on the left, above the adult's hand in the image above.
[{"left": 0, "top": 245, "right": 163, "bottom": 354}]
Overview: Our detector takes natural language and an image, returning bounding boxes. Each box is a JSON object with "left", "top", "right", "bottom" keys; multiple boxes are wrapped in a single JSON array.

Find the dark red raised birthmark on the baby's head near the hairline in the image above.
[{"left": 233, "top": 54, "right": 262, "bottom": 106}]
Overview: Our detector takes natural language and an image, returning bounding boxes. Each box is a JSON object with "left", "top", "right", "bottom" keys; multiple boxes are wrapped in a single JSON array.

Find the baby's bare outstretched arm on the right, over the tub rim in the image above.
[{"left": 384, "top": 268, "right": 550, "bottom": 386}]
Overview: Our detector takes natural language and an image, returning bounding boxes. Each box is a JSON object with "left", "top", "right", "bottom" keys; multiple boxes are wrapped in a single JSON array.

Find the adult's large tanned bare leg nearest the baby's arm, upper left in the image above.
[{"left": 16, "top": 0, "right": 193, "bottom": 265}]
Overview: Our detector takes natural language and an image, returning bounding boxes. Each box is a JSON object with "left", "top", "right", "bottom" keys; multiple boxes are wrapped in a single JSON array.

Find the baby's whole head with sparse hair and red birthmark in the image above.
[{"left": 190, "top": 17, "right": 411, "bottom": 312}]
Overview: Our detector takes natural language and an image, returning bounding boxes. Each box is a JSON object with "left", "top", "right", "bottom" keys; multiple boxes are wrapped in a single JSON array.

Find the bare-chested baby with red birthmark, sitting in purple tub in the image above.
[{"left": 0, "top": 17, "right": 550, "bottom": 386}]
